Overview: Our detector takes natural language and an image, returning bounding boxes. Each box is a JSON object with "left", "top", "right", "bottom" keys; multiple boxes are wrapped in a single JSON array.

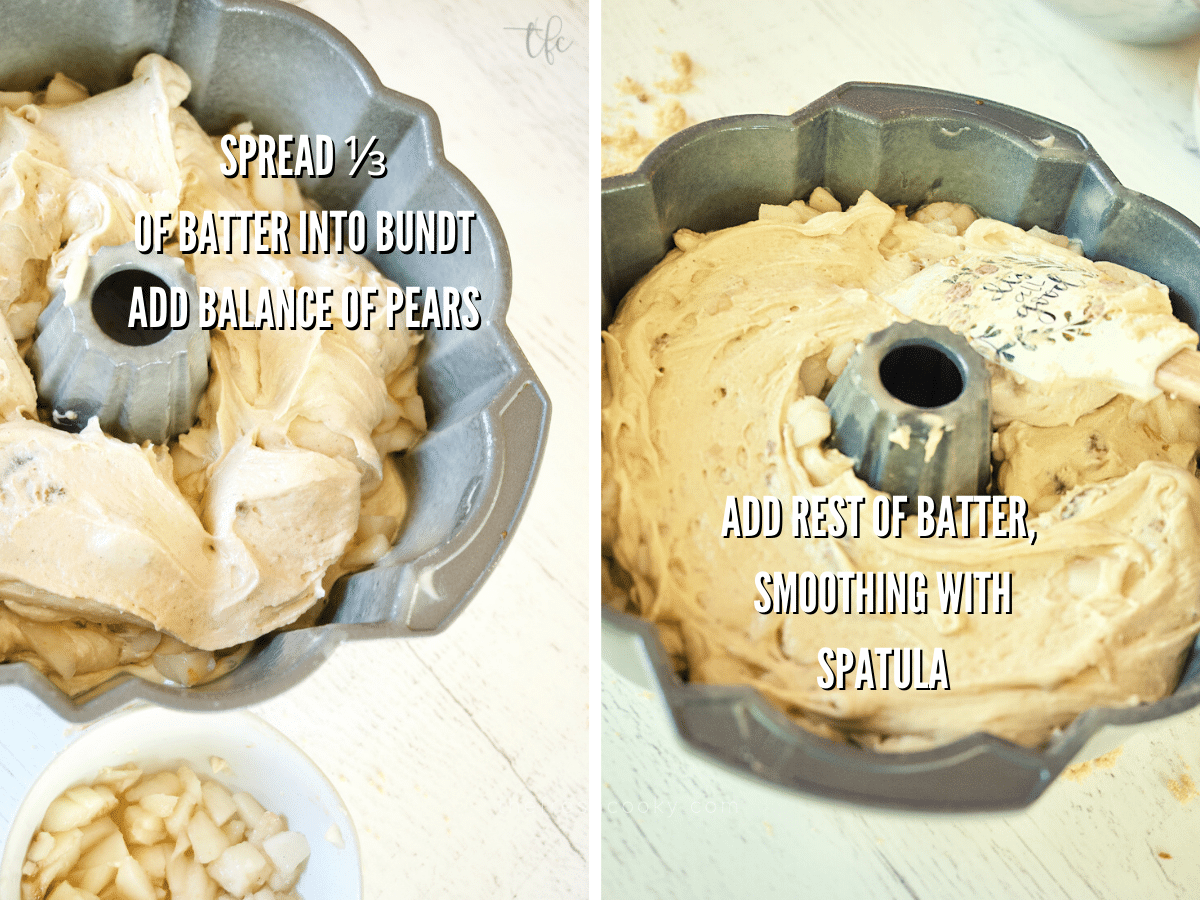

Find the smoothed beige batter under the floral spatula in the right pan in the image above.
[{"left": 601, "top": 190, "right": 1200, "bottom": 750}]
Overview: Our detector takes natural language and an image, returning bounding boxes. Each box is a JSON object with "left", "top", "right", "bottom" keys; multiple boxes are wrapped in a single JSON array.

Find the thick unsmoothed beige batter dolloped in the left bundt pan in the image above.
[{"left": 0, "top": 55, "right": 425, "bottom": 691}]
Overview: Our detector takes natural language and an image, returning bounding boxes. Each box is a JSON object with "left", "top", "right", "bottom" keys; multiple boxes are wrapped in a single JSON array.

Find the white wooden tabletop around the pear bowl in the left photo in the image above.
[{"left": 0, "top": 0, "right": 592, "bottom": 900}]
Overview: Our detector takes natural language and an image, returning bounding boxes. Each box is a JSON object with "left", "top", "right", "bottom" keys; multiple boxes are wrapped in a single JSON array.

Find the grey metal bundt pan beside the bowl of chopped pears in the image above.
[{"left": 0, "top": 0, "right": 550, "bottom": 721}]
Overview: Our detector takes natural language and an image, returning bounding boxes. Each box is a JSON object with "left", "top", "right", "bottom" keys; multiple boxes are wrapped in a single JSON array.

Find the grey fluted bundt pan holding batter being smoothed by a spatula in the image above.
[{"left": 601, "top": 83, "right": 1200, "bottom": 811}]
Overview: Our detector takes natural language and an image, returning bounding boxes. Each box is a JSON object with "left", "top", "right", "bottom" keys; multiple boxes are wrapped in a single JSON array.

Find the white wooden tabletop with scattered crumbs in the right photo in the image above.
[{"left": 599, "top": 0, "right": 1200, "bottom": 900}]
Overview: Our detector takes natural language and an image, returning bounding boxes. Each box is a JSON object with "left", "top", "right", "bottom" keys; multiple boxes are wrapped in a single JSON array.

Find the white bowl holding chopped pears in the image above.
[{"left": 0, "top": 707, "right": 362, "bottom": 900}]
